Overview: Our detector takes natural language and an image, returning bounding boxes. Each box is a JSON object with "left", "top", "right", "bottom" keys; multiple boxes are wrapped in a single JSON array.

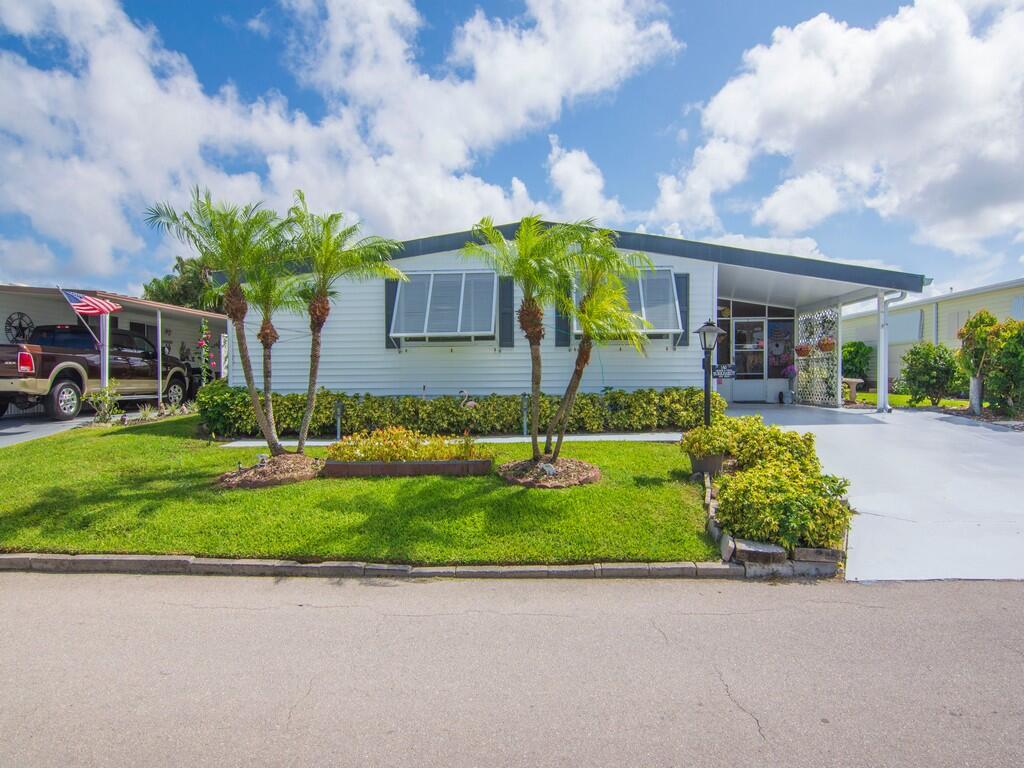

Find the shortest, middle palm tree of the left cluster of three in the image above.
[{"left": 242, "top": 252, "right": 302, "bottom": 456}]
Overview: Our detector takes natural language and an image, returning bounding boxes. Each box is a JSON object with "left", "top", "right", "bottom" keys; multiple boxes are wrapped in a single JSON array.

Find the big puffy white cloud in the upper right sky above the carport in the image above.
[{"left": 652, "top": 0, "right": 1024, "bottom": 253}]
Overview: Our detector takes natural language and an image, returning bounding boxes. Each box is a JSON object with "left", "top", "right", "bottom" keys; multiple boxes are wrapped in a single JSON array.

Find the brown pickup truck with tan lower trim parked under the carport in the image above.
[{"left": 0, "top": 326, "right": 190, "bottom": 421}]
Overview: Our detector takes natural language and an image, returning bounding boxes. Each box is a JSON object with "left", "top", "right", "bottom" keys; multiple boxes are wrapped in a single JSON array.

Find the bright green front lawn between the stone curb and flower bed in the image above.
[{"left": 0, "top": 417, "right": 717, "bottom": 563}]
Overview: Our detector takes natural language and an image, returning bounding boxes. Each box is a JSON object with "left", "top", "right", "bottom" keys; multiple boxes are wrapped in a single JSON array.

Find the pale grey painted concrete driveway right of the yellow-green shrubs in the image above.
[{"left": 729, "top": 406, "right": 1024, "bottom": 581}]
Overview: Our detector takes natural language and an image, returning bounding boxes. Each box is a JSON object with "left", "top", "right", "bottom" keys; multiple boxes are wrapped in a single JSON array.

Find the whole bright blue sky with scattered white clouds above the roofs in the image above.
[{"left": 0, "top": 0, "right": 1024, "bottom": 292}]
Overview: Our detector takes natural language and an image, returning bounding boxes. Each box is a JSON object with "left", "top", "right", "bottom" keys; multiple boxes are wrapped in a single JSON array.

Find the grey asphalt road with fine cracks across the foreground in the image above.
[{"left": 0, "top": 573, "right": 1024, "bottom": 768}]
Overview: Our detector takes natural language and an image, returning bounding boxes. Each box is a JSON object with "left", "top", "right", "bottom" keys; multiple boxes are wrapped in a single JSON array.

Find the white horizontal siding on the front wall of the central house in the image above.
[{"left": 229, "top": 252, "right": 714, "bottom": 395}]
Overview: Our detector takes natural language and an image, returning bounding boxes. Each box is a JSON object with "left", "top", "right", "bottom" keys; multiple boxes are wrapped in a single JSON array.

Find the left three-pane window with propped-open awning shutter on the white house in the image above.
[{"left": 391, "top": 271, "right": 498, "bottom": 338}]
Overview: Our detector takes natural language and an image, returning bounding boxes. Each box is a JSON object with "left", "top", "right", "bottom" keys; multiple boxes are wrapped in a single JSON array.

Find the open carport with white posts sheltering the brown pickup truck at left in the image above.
[{"left": 0, "top": 286, "right": 227, "bottom": 416}]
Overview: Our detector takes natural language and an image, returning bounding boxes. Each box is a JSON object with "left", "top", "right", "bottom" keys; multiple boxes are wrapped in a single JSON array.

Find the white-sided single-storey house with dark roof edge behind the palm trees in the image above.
[{"left": 229, "top": 224, "right": 926, "bottom": 406}]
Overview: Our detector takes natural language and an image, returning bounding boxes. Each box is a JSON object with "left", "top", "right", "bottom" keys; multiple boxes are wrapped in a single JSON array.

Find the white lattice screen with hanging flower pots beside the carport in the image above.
[{"left": 796, "top": 306, "right": 843, "bottom": 408}]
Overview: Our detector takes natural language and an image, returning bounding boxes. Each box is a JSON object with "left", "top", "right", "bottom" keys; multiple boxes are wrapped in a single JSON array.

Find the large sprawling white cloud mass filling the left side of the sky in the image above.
[{"left": 0, "top": 0, "right": 679, "bottom": 283}]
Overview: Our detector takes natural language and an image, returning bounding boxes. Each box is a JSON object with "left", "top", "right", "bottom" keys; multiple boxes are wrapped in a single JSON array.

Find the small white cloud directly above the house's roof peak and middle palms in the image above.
[{"left": 548, "top": 135, "right": 626, "bottom": 226}]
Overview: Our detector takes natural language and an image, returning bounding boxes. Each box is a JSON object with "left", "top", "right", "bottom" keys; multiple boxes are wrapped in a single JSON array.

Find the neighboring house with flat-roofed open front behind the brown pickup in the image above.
[{"left": 0, "top": 285, "right": 227, "bottom": 415}]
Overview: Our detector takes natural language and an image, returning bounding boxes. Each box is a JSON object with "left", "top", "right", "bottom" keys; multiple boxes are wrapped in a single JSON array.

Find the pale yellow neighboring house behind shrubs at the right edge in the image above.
[{"left": 843, "top": 278, "right": 1024, "bottom": 381}]
